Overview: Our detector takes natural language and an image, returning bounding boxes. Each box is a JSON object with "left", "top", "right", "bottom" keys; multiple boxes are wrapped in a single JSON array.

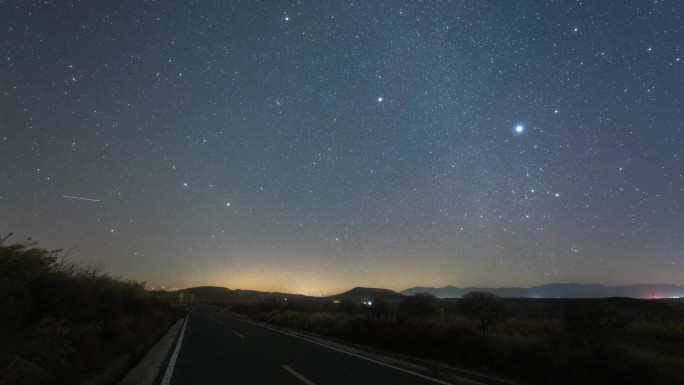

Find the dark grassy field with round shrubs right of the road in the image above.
[{"left": 218, "top": 292, "right": 684, "bottom": 384}]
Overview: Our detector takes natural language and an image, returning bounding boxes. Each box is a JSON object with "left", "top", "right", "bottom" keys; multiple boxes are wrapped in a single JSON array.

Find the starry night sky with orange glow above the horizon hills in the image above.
[{"left": 0, "top": 0, "right": 684, "bottom": 295}]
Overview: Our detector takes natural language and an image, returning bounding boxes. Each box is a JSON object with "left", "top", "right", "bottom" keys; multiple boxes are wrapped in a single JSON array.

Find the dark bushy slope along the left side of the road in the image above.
[{"left": 0, "top": 234, "right": 181, "bottom": 385}]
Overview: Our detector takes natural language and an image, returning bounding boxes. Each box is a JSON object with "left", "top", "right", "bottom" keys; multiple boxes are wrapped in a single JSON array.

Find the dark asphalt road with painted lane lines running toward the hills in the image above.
[{"left": 165, "top": 305, "right": 452, "bottom": 385}]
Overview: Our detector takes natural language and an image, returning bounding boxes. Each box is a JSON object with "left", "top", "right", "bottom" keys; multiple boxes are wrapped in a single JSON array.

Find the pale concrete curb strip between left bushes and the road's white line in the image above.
[{"left": 118, "top": 319, "right": 184, "bottom": 385}]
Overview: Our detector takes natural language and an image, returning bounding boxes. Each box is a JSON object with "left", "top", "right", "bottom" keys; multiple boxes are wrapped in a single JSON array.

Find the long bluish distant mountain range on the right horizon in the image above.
[{"left": 401, "top": 283, "right": 684, "bottom": 298}]
